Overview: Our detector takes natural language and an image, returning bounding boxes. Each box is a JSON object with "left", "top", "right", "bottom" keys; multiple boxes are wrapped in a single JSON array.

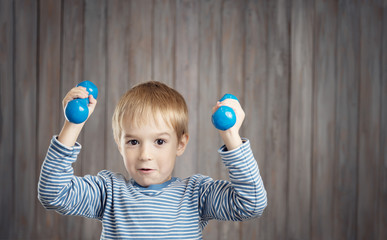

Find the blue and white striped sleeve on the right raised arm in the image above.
[{"left": 199, "top": 139, "right": 267, "bottom": 221}]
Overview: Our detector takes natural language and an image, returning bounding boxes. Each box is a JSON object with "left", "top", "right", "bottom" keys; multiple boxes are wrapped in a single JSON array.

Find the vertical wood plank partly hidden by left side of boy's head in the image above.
[{"left": 104, "top": 0, "right": 130, "bottom": 175}]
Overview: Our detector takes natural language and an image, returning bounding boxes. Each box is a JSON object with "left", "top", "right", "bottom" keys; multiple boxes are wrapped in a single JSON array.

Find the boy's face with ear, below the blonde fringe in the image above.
[{"left": 118, "top": 114, "right": 188, "bottom": 187}]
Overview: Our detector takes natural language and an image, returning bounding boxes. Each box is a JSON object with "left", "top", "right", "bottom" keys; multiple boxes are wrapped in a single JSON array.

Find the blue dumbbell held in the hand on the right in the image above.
[{"left": 212, "top": 93, "right": 238, "bottom": 131}]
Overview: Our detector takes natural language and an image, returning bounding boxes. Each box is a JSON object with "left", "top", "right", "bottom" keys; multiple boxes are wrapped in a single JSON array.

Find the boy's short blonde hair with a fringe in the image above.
[{"left": 112, "top": 81, "right": 188, "bottom": 144}]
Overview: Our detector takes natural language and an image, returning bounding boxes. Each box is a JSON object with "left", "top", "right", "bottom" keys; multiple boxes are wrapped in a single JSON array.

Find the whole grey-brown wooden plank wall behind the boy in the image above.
[{"left": 0, "top": 0, "right": 387, "bottom": 240}]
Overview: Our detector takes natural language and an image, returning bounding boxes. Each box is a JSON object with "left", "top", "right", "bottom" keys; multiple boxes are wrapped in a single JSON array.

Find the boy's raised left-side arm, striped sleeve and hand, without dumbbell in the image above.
[{"left": 38, "top": 84, "right": 106, "bottom": 218}]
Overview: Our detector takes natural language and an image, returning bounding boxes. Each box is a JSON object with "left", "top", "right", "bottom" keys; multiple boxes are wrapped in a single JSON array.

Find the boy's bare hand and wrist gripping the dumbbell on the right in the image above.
[{"left": 212, "top": 99, "right": 245, "bottom": 150}]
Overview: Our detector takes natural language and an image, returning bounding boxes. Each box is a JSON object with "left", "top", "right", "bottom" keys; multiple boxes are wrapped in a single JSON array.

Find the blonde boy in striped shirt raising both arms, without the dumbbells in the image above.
[{"left": 38, "top": 82, "right": 266, "bottom": 239}]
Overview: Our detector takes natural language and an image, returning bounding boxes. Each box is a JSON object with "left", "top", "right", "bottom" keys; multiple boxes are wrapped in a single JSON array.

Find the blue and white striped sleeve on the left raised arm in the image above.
[{"left": 38, "top": 136, "right": 106, "bottom": 219}]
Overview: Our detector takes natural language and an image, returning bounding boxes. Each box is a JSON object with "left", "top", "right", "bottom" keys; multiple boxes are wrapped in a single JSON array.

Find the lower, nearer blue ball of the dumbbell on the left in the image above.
[{"left": 65, "top": 98, "right": 89, "bottom": 124}]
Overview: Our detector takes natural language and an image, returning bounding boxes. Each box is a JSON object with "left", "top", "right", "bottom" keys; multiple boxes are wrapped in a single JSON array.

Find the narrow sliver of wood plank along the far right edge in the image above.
[{"left": 378, "top": 0, "right": 387, "bottom": 240}]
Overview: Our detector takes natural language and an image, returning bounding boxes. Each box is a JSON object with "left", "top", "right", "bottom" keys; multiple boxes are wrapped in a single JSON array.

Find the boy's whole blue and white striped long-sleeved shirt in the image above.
[{"left": 38, "top": 137, "right": 266, "bottom": 239}]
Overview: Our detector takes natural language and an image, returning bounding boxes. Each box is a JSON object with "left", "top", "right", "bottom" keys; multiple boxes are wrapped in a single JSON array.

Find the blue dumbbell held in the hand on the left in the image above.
[{"left": 65, "top": 80, "right": 98, "bottom": 124}]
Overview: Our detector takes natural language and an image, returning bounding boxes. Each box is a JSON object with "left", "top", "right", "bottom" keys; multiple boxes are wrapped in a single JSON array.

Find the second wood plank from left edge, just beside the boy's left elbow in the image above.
[{"left": 14, "top": 0, "right": 38, "bottom": 239}]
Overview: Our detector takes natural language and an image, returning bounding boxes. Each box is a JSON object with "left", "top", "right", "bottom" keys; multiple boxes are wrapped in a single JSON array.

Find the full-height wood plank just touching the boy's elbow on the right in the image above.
[{"left": 261, "top": 0, "right": 290, "bottom": 239}]
